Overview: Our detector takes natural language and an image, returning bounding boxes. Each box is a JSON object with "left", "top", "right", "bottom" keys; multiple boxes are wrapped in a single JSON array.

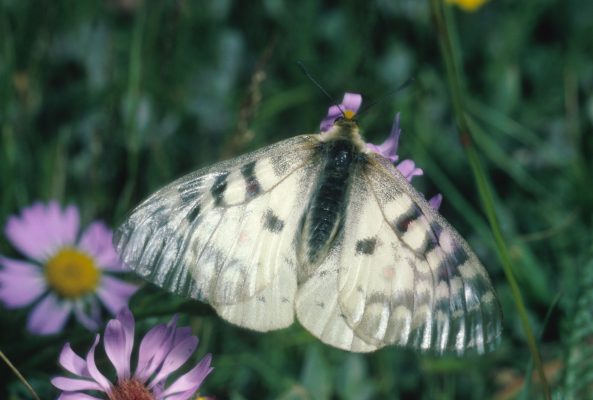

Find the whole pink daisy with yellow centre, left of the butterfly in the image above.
[{"left": 0, "top": 201, "right": 138, "bottom": 335}]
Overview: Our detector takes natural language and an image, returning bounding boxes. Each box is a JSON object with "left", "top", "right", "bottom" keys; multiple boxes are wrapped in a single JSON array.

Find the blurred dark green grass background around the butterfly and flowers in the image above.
[{"left": 0, "top": 0, "right": 593, "bottom": 400}]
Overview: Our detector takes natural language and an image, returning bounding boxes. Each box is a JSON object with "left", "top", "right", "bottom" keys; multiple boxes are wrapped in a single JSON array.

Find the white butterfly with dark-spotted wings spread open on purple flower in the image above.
[{"left": 114, "top": 94, "right": 502, "bottom": 354}]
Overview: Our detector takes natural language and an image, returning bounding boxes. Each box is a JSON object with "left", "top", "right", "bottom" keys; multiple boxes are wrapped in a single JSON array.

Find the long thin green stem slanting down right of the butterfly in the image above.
[{"left": 430, "top": 0, "right": 551, "bottom": 399}]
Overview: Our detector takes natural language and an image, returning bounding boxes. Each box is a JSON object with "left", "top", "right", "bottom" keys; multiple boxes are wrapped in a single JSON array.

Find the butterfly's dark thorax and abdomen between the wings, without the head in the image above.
[{"left": 298, "top": 139, "right": 360, "bottom": 275}]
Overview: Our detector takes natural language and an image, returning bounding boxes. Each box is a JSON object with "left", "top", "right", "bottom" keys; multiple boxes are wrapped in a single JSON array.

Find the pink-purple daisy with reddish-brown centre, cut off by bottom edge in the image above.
[{"left": 51, "top": 308, "right": 212, "bottom": 400}]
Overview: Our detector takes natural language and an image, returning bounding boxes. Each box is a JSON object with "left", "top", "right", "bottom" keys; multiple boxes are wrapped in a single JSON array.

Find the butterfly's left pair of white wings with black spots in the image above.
[{"left": 114, "top": 135, "right": 318, "bottom": 331}]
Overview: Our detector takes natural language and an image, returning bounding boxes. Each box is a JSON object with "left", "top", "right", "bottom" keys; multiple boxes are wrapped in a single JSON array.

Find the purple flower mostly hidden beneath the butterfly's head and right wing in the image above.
[{"left": 320, "top": 93, "right": 443, "bottom": 210}]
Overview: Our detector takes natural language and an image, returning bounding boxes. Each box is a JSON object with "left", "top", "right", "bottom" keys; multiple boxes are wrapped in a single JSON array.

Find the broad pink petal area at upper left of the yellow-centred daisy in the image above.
[{"left": 5, "top": 201, "right": 79, "bottom": 263}]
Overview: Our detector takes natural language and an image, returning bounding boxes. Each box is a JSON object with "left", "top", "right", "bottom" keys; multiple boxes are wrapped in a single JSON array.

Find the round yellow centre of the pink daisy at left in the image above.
[{"left": 45, "top": 248, "right": 101, "bottom": 299}]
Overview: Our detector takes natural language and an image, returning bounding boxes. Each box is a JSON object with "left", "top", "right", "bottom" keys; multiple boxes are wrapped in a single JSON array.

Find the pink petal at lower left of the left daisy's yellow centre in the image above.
[{"left": 27, "top": 293, "right": 72, "bottom": 335}]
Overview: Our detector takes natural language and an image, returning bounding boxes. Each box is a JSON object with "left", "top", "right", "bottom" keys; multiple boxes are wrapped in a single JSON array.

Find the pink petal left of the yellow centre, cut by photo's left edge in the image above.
[{"left": 0, "top": 256, "right": 47, "bottom": 308}]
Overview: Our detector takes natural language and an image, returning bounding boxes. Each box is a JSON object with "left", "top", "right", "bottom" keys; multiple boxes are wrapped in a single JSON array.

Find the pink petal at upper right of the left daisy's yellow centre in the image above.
[{"left": 78, "top": 221, "right": 123, "bottom": 271}]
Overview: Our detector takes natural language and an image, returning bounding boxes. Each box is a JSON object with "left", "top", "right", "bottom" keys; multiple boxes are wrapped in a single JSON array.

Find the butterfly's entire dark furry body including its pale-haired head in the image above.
[{"left": 297, "top": 120, "right": 366, "bottom": 280}]
